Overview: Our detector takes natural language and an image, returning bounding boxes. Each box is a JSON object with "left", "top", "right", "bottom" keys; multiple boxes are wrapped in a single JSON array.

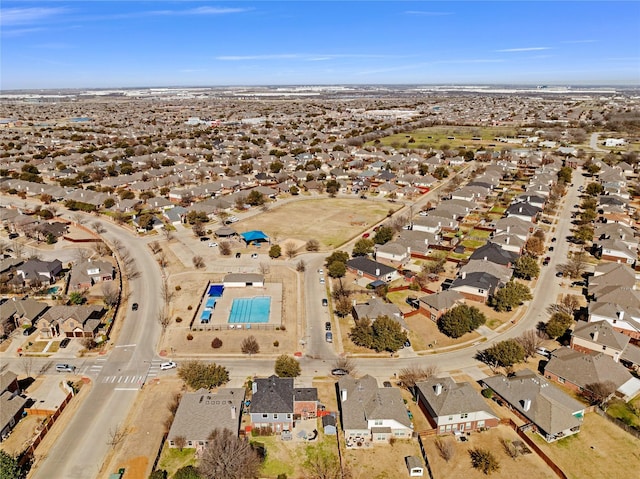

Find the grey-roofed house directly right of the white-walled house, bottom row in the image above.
[{"left": 415, "top": 377, "right": 500, "bottom": 434}]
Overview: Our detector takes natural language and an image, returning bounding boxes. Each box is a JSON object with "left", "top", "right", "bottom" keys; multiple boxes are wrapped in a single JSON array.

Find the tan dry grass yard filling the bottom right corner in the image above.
[{"left": 528, "top": 413, "right": 640, "bottom": 479}]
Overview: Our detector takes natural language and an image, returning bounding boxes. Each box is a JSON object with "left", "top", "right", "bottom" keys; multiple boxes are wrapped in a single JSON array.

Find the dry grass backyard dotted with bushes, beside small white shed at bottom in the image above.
[{"left": 423, "top": 426, "right": 556, "bottom": 479}]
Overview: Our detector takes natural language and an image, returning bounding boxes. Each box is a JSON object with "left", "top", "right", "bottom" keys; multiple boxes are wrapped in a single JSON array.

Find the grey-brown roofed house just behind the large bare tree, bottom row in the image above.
[{"left": 167, "top": 388, "right": 245, "bottom": 451}]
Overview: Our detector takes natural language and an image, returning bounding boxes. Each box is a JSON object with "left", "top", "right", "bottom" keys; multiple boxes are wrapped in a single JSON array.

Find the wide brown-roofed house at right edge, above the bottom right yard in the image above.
[{"left": 544, "top": 348, "right": 640, "bottom": 401}]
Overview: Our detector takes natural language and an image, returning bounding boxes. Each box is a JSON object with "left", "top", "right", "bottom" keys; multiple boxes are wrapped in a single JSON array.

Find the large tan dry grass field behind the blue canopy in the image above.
[{"left": 235, "top": 198, "right": 398, "bottom": 250}]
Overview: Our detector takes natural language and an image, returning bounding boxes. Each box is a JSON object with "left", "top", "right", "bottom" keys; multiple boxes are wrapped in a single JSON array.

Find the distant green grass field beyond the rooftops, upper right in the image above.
[{"left": 372, "top": 126, "right": 518, "bottom": 149}]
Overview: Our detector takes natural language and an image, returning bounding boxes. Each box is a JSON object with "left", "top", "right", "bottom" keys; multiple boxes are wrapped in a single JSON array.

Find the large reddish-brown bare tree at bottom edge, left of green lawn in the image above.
[{"left": 198, "top": 429, "right": 261, "bottom": 479}]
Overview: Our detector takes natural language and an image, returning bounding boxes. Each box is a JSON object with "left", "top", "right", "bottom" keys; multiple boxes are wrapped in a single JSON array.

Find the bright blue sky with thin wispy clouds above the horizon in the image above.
[{"left": 0, "top": 0, "right": 640, "bottom": 90}]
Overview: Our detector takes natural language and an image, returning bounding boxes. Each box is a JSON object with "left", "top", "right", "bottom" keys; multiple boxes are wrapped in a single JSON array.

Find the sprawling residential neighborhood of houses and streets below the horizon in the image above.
[{"left": 0, "top": 87, "right": 640, "bottom": 479}]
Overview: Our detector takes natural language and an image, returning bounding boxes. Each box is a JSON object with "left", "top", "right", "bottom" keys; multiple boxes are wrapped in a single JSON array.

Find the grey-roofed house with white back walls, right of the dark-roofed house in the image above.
[{"left": 337, "top": 374, "right": 413, "bottom": 447}]
